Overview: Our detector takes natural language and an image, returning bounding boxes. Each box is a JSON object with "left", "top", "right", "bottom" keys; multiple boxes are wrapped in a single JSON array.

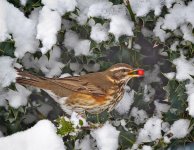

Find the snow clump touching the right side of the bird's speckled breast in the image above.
[{"left": 115, "top": 86, "right": 134, "bottom": 114}]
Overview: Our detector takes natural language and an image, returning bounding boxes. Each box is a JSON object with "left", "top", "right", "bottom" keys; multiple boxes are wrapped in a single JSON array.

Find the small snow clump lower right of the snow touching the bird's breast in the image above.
[{"left": 130, "top": 107, "right": 148, "bottom": 125}]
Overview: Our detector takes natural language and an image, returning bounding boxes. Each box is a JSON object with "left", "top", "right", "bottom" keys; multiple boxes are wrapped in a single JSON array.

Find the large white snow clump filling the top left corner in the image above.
[{"left": 0, "top": 0, "right": 38, "bottom": 58}]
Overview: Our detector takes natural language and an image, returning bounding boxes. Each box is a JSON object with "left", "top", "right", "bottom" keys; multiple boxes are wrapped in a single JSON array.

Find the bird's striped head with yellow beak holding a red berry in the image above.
[{"left": 106, "top": 63, "right": 144, "bottom": 82}]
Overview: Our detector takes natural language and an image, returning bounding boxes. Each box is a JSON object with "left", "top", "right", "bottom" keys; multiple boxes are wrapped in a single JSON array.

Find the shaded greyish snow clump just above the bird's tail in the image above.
[{"left": 22, "top": 46, "right": 65, "bottom": 77}]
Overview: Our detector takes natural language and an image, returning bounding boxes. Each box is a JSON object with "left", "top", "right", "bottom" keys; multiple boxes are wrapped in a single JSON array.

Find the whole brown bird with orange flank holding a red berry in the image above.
[{"left": 16, "top": 63, "right": 144, "bottom": 114}]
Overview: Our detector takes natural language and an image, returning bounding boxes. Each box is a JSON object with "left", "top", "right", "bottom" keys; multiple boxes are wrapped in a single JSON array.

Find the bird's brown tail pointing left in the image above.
[{"left": 15, "top": 68, "right": 47, "bottom": 89}]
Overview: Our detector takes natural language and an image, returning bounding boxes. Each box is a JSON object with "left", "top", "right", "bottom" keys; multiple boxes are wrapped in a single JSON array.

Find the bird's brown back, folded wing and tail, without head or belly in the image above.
[{"left": 17, "top": 70, "right": 110, "bottom": 96}]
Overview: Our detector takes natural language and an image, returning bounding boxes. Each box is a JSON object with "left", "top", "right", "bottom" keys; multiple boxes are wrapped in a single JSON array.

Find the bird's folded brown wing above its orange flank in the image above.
[{"left": 50, "top": 77, "right": 106, "bottom": 96}]
